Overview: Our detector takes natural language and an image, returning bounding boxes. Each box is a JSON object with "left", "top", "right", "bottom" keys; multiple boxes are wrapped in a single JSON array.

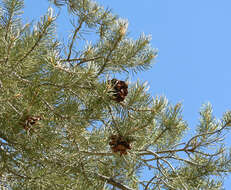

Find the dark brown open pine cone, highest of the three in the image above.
[{"left": 109, "top": 79, "right": 128, "bottom": 102}]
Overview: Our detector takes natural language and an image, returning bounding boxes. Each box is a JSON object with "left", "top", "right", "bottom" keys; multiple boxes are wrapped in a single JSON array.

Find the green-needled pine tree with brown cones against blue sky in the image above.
[{"left": 0, "top": 0, "right": 231, "bottom": 190}]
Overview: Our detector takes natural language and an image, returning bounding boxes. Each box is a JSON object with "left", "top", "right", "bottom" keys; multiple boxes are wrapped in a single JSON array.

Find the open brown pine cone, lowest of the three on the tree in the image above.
[{"left": 109, "top": 135, "right": 131, "bottom": 156}]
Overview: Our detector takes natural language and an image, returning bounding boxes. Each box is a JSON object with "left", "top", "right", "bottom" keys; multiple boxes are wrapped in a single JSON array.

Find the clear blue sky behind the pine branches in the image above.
[{"left": 22, "top": 0, "right": 231, "bottom": 189}]
